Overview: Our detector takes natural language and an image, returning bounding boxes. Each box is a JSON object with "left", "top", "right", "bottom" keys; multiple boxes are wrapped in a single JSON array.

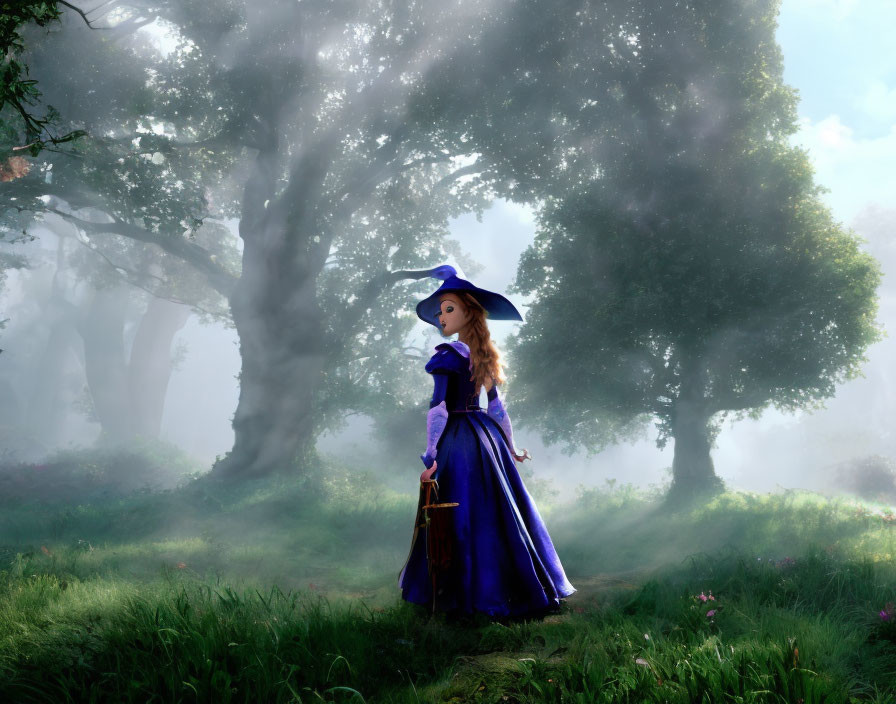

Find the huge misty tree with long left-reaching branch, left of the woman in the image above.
[{"left": 5, "top": 2, "right": 504, "bottom": 476}]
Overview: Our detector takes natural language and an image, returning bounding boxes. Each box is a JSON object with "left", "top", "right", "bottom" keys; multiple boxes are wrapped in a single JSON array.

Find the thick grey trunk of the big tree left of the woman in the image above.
[{"left": 213, "top": 120, "right": 341, "bottom": 478}]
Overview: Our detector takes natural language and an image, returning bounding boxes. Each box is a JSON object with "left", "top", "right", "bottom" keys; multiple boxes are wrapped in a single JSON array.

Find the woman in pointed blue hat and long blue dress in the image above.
[{"left": 398, "top": 266, "right": 575, "bottom": 617}]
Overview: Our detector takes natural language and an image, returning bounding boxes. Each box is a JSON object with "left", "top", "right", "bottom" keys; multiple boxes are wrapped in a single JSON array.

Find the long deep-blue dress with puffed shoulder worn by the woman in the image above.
[{"left": 398, "top": 342, "right": 576, "bottom": 617}]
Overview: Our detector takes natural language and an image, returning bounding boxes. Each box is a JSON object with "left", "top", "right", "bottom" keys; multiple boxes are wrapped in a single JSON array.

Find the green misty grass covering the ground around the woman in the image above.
[{"left": 0, "top": 448, "right": 896, "bottom": 704}]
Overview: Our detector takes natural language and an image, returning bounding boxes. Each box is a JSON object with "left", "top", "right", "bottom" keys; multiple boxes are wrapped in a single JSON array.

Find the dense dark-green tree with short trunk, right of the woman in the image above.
[{"left": 509, "top": 1, "right": 880, "bottom": 506}]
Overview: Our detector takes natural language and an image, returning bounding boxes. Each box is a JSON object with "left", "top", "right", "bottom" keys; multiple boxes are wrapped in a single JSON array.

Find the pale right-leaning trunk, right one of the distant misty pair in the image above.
[{"left": 128, "top": 296, "right": 190, "bottom": 438}]
